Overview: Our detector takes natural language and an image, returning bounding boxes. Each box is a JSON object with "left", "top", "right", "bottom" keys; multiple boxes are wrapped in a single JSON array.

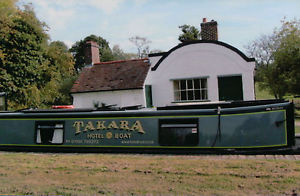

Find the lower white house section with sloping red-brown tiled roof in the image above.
[{"left": 71, "top": 59, "right": 150, "bottom": 108}]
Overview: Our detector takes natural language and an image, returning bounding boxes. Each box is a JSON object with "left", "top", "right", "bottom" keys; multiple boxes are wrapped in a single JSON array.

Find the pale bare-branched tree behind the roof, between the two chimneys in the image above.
[{"left": 129, "top": 36, "right": 151, "bottom": 59}]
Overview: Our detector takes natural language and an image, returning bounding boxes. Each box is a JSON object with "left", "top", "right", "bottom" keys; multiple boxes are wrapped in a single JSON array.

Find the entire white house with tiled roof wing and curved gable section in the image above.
[{"left": 71, "top": 20, "right": 255, "bottom": 108}]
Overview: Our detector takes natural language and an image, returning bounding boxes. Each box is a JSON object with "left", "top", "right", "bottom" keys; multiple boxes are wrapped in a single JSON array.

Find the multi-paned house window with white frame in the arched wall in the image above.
[{"left": 173, "top": 78, "right": 208, "bottom": 101}]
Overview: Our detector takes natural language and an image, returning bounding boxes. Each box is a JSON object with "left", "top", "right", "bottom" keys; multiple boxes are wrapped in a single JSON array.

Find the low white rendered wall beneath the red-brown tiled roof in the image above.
[{"left": 72, "top": 89, "right": 145, "bottom": 108}]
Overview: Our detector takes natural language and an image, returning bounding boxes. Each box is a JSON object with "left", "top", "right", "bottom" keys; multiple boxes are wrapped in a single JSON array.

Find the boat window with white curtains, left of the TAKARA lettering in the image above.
[{"left": 36, "top": 122, "right": 64, "bottom": 144}]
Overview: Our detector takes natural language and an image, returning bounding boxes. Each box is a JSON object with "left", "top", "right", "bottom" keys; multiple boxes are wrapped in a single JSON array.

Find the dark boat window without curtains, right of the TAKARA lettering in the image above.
[{"left": 159, "top": 119, "right": 199, "bottom": 146}]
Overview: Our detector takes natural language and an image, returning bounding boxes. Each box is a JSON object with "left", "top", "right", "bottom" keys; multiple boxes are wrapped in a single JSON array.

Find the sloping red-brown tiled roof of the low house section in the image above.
[{"left": 71, "top": 59, "right": 150, "bottom": 93}]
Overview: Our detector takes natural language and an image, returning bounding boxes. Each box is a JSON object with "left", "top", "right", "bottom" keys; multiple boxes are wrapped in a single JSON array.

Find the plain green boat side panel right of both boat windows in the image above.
[{"left": 199, "top": 110, "right": 287, "bottom": 148}]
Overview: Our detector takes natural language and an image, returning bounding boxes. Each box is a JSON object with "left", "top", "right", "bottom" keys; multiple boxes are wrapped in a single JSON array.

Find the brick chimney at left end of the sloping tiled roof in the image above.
[{"left": 85, "top": 41, "right": 100, "bottom": 65}]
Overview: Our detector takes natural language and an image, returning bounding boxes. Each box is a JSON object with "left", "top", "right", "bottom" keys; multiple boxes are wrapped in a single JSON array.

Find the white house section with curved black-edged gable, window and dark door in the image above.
[{"left": 145, "top": 40, "right": 255, "bottom": 106}]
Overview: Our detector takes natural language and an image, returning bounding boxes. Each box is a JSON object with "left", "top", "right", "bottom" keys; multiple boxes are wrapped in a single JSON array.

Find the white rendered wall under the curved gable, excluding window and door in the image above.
[{"left": 145, "top": 43, "right": 255, "bottom": 106}]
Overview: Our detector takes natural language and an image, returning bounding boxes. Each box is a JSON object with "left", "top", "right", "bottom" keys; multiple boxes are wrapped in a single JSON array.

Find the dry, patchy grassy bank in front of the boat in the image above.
[{"left": 0, "top": 152, "right": 300, "bottom": 195}]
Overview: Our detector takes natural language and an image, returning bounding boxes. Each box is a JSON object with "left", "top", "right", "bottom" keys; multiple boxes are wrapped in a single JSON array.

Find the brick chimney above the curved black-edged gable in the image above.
[{"left": 201, "top": 18, "right": 218, "bottom": 41}]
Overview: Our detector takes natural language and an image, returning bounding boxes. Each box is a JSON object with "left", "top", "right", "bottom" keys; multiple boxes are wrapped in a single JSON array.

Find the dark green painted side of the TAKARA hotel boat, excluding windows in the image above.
[{"left": 0, "top": 103, "right": 288, "bottom": 148}]
